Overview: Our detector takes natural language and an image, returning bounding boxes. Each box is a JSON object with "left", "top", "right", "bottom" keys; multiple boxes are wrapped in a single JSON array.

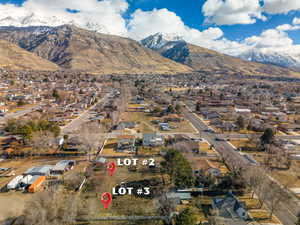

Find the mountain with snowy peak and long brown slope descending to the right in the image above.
[{"left": 141, "top": 34, "right": 300, "bottom": 77}]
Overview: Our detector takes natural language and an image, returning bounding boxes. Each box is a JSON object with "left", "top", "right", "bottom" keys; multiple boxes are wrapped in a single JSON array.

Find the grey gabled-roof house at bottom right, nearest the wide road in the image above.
[{"left": 212, "top": 193, "right": 249, "bottom": 225}]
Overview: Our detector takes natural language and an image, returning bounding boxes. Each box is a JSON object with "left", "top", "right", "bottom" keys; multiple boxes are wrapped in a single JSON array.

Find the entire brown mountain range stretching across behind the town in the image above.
[{"left": 0, "top": 25, "right": 300, "bottom": 77}]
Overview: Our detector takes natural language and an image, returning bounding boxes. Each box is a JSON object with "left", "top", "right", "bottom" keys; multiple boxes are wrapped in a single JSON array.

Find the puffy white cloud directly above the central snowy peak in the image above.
[{"left": 128, "top": 9, "right": 244, "bottom": 54}]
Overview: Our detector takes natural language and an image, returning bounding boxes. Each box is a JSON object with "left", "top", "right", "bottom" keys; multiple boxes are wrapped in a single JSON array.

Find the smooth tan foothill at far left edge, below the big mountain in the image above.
[{"left": 0, "top": 40, "right": 59, "bottom": 70}]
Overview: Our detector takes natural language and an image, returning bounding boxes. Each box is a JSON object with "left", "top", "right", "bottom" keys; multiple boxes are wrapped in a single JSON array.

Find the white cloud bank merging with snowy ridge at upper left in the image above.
[{"left": 0, "top": 0, "right": 128, "bottom": 35}]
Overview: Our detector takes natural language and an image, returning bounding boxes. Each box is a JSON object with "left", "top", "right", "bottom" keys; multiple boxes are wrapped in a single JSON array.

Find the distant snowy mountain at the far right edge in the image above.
[{"left": 238, "top": 48, "right": 300, "bottom": 71}]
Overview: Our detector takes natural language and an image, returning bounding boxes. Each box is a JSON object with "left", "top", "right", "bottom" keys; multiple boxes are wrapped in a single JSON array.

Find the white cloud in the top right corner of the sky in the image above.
[{"left": 263, "top": 0, "right": 300, "bottom": 14}]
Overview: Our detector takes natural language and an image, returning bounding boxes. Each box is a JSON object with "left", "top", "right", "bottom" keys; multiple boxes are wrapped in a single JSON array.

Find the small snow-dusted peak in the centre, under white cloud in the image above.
[{"left": 141, "top": 33, "right": 184, "bottom": 50}]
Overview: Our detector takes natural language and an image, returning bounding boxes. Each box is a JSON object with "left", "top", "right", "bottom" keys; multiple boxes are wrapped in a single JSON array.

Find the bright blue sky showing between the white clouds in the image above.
[{"left": 130, "top": 0, "right": 300, "bottom": 44}]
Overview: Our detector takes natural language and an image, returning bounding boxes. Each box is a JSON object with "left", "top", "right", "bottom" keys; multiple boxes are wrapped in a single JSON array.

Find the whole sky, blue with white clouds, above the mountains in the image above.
[{"left": 0, "top": 0, "right": 300, "bottom": 55}]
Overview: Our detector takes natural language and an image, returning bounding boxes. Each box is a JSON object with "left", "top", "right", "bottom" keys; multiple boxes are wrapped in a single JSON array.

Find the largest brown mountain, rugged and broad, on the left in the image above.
[{"left": 0, "top": 25, "right": 192, "bottom": 74}]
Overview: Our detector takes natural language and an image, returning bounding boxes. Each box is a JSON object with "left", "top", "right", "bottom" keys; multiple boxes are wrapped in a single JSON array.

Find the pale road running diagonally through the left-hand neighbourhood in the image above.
[{"left": 61, "top": 93, "right": 111, "bottom": 134}]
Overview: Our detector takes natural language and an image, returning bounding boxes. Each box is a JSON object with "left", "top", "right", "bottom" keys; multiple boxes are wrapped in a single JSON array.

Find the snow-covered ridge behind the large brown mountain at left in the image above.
[{"left": 0, "top": 13, "right": 109, "bottom": 34}]
